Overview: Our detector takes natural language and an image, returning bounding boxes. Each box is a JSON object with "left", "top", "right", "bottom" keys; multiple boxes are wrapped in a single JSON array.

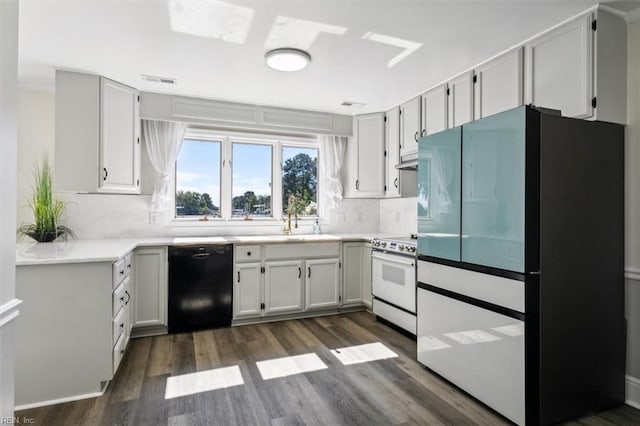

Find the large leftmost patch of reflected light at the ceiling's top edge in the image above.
[{"left": 169, "top": 0, "right": 255, "bottom": 44}]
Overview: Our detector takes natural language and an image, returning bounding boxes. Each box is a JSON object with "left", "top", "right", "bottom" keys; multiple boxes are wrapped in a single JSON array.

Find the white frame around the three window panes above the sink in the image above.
[{"left": 170, "top": 128, "right": 322, "bottom": 226}]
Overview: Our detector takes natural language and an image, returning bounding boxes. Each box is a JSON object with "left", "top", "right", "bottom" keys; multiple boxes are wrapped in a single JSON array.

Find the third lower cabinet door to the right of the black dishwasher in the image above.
[{"left": 305, "top": 259, "right": 341, "bottom": 310}]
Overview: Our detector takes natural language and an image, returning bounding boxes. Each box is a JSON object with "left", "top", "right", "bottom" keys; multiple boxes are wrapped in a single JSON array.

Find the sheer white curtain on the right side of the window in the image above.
[{"left": 320, "top": 135, "right": 348, "bottom": 208}]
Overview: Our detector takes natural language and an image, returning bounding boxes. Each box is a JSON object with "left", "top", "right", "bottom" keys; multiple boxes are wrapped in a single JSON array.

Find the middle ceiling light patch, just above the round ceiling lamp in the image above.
[{"left": 264, "top": 16, "right": 347, "bottom": 50}]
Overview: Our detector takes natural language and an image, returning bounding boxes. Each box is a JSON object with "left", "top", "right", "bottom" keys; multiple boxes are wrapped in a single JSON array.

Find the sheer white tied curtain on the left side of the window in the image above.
[{"left": 142, "top": 120, "right": 187, "bottom": 211}]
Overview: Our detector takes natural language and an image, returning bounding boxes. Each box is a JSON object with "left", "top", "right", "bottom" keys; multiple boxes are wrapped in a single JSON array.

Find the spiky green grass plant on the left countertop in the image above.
[{"left": 18, "top": 156, "right": 75, "bottom": 243}]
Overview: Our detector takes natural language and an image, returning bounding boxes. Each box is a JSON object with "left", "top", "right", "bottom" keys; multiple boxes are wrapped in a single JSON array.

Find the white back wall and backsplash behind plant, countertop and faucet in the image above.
[{"left": 17, "top": 90, "right": 380, "bottom": 239}]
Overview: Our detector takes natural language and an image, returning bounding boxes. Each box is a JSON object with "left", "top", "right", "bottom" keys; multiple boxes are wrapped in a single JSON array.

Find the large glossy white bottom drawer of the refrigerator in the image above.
[{"left": 417, "top": 289, "right": 525, "bottom": 424}]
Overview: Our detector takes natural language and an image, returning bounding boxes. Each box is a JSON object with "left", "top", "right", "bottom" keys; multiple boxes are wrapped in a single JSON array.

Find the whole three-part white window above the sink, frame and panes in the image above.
[{"left": 175, "top": 129, "right": 319, "bottom": 221}]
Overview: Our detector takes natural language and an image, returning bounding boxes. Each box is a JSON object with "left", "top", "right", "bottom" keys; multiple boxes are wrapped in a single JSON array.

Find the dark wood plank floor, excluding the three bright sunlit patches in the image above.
[{"left": 16, "top": 312, "right": 640, "bottom": 426}]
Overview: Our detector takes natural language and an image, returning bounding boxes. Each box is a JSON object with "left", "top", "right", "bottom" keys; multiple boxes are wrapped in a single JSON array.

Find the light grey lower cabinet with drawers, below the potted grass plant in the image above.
[{"left": 15, "top": 251, "right": 135, "bottom": 409}]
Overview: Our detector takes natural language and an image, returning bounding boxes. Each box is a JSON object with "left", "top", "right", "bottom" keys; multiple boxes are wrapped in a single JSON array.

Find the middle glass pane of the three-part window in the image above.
[{"left": 231, "top": 142, "right": 272, "bottom": 217}]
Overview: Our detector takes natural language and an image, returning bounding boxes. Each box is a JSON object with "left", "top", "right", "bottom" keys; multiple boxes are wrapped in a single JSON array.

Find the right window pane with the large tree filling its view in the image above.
[{"left": 282, "top": 146, "right": 318, "bottom": 216}]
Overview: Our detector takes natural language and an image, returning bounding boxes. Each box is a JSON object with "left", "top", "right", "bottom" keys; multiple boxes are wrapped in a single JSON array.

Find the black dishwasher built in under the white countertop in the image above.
[{"left": 169, "top": 244, "right": 233, "bottom": 333}]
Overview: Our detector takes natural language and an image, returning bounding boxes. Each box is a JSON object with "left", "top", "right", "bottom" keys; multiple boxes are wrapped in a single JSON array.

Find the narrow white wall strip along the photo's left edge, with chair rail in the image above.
[{"left": 0, "top": 0, "right": 18, "bottom": 423}]
